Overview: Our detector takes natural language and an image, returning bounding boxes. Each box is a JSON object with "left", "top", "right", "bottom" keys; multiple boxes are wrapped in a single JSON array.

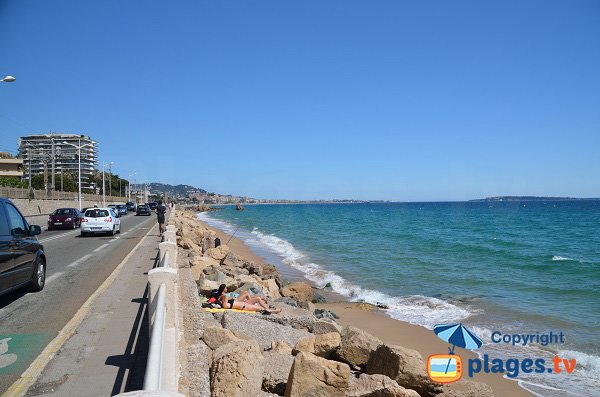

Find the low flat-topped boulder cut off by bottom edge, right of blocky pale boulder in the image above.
[{"left": 346, "top": 372, "right": 420, "bottom": 397}]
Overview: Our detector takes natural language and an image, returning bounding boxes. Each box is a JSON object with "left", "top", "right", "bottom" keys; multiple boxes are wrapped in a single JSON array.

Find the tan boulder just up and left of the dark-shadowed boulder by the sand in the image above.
[{"left": 335, "top": 327, "right": 382, "bottom": 368}]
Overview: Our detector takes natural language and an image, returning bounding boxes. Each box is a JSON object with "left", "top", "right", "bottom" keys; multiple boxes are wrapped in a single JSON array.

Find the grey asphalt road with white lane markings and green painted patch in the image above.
[{"left": 0, "top": 213, "right": 159, "bottom": 395}]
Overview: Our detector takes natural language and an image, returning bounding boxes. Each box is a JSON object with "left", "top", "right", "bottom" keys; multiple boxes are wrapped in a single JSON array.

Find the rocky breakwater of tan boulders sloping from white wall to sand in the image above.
[{"left": 170, "top": 211, "right": 492, "bottom": 397}]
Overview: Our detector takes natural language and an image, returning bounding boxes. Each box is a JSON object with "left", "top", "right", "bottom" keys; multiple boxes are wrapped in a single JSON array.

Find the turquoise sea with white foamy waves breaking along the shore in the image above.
[{"left": 198, "top": 200, "right": 600, "bottom": 397}]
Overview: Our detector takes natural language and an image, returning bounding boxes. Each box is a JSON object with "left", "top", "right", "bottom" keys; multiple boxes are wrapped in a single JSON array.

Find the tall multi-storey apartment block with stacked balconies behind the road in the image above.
[{"left": 18, "top": 133, "right": 98, "bottom": 189}]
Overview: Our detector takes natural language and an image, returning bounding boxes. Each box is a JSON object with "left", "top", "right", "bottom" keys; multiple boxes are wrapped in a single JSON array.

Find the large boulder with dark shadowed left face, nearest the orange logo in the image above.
[{"left": 366, "top": 345, "right": 442, "bottom": 397}]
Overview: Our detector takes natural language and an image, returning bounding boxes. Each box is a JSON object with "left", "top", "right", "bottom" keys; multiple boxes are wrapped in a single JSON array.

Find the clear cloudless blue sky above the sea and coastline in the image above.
[{"left": 0, "top": 0, "right": 600, "bottom": 201}]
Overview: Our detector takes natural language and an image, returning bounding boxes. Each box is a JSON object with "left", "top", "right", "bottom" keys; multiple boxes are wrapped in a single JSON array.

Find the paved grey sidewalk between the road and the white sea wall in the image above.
[{"left": 26, "top": 225, "right": 160, "bottom": 396}]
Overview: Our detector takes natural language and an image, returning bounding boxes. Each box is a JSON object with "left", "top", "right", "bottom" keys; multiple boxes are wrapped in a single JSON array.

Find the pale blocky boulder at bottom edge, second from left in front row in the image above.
[{"left": 285, "top": 352, "right": 350, "bottom": 397}]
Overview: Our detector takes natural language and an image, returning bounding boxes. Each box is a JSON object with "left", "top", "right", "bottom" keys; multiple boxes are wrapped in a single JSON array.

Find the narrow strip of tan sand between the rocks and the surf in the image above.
[{"left": 193, "top": 213, "right": 534, "bottom": 397}]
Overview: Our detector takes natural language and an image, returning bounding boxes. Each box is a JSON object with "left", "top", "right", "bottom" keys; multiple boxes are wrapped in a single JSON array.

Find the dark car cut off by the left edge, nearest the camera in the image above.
[{"left": 0, "top": 198, "right": 46, "bottom": 295}]
